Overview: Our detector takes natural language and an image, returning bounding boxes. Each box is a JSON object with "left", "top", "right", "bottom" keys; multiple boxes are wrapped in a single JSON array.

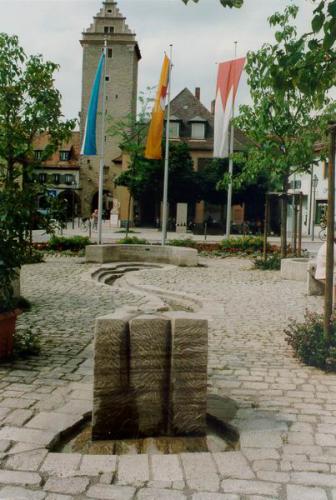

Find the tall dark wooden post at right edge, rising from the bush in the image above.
[{"left": 324, "top": 123, "right": 336, "bottom": 341}]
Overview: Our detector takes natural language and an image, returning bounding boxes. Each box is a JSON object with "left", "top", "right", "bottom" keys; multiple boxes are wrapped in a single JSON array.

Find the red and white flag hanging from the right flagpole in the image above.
[{"left": 214, "top": 57, "right": 245, "bottom": 158}]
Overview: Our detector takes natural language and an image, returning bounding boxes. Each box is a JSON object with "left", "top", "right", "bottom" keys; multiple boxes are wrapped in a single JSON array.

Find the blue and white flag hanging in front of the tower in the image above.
[{"left": 81, "top": 52, "right": 105, "bottom": 156}]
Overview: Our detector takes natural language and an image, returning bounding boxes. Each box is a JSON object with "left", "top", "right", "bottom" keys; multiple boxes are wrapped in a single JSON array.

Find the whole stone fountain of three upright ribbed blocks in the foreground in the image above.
[{"left": 92, "top": 311, "right": 208, "bottom": 440}]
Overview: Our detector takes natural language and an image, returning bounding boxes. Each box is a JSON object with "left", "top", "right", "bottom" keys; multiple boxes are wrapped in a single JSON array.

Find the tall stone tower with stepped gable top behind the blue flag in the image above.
[{"left": 80, "top": 1, "right": 141, "bottom": 216}]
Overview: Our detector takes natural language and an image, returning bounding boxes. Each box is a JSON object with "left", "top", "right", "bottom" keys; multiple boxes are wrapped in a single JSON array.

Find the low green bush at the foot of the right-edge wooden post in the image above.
[{"left": 285, "top": 311, "right": 336, "bottom": 371}]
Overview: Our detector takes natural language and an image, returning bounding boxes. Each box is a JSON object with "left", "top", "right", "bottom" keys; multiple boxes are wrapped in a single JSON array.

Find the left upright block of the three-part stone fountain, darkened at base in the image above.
[{"left": 92, "top": 311, "right": 137, "bottom": 439}]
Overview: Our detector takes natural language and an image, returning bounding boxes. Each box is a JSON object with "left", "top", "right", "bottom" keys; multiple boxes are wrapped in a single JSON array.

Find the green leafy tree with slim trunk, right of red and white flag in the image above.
[{"left": 235, "top": 6, "right": 335, "bottom": 256}]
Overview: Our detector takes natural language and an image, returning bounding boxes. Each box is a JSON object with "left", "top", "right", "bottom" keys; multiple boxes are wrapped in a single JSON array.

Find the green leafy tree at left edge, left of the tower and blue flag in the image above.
[{"left": 0, "top": 33, "right": 75, "bottom": 260}]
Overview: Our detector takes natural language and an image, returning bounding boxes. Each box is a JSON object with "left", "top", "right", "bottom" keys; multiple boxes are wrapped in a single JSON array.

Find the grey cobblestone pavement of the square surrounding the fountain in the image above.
[{"left": 0, "top": 258, "right": 336, "bottom": 500}]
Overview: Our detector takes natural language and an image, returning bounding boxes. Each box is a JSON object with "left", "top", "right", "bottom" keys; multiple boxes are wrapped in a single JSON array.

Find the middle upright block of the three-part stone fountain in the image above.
[{"left": 130, "top": 315, "right": 171, "bottom": 436}]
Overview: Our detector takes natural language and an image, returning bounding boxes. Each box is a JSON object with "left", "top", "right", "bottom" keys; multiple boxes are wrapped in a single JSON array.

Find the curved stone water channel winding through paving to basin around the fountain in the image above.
[{"left": 55, "top": 263, "right": 239, "bottom": 455}]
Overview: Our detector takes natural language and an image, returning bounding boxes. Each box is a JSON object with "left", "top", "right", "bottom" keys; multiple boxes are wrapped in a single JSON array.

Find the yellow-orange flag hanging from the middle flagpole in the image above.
[{"left": 145, "top": 56, "right": 170, "bottom": 160}]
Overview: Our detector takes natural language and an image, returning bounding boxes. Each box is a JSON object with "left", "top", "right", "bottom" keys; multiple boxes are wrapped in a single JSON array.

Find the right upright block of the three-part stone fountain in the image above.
[{"left": 169, "top": 313, "right": 208, "bottom": 436}]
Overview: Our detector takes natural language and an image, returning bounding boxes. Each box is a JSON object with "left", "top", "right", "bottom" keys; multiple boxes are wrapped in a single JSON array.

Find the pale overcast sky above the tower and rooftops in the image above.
[{"left": 0, "top": 0, "right": 313, "bottom": 118}]
